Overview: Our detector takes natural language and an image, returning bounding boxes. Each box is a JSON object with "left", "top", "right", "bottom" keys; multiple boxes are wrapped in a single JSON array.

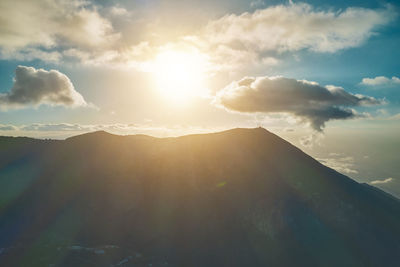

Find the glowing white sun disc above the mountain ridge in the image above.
[{"left": 153, "top": 50, "right": 207, "bottom": 104}]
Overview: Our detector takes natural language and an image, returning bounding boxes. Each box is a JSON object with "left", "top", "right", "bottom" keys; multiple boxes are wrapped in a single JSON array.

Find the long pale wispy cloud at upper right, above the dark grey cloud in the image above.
[{"left": 205, "top": 3, "right": 396, "bottom": 52}]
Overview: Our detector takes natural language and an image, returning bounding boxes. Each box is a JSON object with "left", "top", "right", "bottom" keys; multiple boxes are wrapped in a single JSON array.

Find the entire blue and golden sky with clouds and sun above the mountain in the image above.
[{"left": 0, "top": 0, "right": 400, "bottom": 196}]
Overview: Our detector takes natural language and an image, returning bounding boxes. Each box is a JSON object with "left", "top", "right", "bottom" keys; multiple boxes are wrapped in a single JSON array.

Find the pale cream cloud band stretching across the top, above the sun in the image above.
[{"left": 0, "top": 0, "right": 397, "bottom": 70}]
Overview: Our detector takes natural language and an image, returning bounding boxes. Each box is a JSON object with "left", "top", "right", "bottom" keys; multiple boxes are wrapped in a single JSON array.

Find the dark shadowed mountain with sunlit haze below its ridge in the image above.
[{"left": 0, "top": 128, "right": 400, "bottom": 266}]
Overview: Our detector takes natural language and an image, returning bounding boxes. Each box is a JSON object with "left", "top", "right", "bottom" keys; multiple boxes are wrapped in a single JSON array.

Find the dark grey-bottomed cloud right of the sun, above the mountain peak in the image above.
[{"left": 214, "top": 76, "right": 383, "bottom": 131}]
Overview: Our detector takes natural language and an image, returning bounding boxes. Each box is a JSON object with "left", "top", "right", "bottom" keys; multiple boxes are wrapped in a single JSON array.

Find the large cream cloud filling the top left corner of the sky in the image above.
[{"left": 0, "top": 0, "right": 120, "bottom": 60}]
